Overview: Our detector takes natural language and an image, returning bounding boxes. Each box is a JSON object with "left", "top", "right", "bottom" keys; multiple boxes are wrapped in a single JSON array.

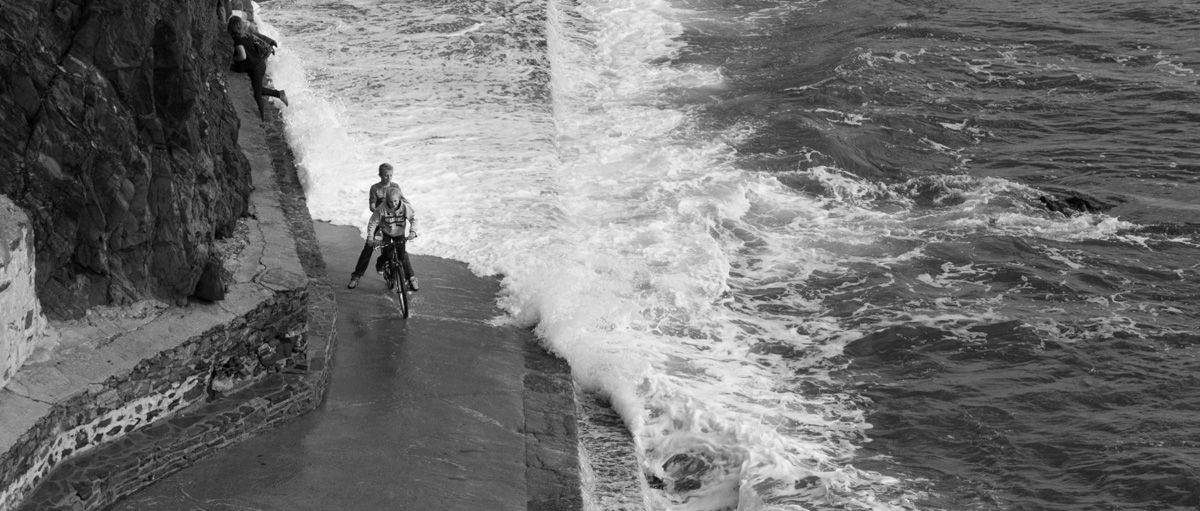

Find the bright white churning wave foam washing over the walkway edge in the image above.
[{"left": 253, "top": 0, "right": 1142, "bottom": 510}]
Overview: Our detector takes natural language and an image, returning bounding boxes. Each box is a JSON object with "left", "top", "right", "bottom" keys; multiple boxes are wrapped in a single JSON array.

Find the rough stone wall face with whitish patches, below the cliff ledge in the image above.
[{"left": 0, "top": 287, "right": 304, "bottom": 510}]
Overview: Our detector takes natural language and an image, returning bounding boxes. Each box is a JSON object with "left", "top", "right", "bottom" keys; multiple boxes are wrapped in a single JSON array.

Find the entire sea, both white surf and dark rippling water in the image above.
[{"left": 258, "top": 0, "right": 1200, "bottom": 511}]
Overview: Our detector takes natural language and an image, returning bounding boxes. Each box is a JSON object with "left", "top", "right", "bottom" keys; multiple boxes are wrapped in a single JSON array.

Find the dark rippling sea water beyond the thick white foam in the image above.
[{"left": 674, "top": 0, "right": 1200, "bottom": 510}]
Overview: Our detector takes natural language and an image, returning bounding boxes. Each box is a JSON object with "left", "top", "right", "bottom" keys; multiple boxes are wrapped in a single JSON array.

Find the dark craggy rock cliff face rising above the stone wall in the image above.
[{"left": 0, "top": 0, "right": 250, "bottom": 318}]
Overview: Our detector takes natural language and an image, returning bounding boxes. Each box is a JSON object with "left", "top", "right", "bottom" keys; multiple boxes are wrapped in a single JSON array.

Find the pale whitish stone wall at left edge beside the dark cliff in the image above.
[{"left": 0, "top": 196, "right": 46, "bottom": 389}]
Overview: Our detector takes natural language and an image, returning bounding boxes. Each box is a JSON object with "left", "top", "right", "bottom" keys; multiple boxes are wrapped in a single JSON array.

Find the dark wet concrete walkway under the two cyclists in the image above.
[{"left": 110, "top": 222, "right": 535, "bottom": 511}]
